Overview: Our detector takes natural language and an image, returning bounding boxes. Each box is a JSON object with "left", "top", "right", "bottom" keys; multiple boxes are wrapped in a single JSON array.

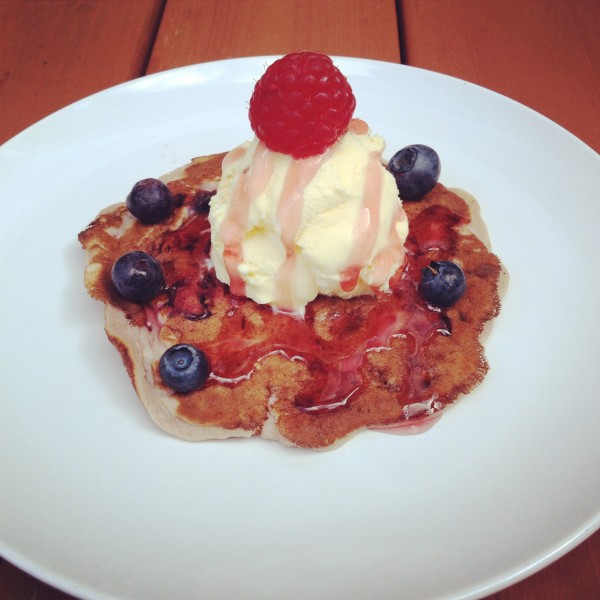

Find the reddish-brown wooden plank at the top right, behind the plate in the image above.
[{"left": 400, "top": 0, "right": 600, "bottom": 151}]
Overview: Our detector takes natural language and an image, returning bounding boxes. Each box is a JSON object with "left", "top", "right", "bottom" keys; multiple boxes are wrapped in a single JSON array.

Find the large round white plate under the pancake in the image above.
[{"left": 0, "top": 57, "right": 600, "bottom": 600}]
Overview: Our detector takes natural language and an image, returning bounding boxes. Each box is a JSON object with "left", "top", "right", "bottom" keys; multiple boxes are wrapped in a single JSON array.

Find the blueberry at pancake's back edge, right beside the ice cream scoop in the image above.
[{"left": 388, "top": 144, "right": 441, "bottom": 200}]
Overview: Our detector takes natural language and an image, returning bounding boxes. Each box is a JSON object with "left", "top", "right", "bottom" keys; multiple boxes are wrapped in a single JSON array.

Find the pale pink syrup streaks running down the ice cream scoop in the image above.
[{"left": 213, "top": 119, "right": 406, "bottom": 310}]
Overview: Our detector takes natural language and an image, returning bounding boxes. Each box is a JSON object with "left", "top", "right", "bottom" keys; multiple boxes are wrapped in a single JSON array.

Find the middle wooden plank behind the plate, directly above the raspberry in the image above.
[{"left": 148, "top": 0, "right": 400, "bottom": 73}]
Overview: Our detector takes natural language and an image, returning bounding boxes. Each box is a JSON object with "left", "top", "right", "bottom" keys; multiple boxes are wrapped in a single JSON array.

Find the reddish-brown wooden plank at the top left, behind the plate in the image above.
[{"left": 0, "top": 0, "right": 163, "bottom": 143}]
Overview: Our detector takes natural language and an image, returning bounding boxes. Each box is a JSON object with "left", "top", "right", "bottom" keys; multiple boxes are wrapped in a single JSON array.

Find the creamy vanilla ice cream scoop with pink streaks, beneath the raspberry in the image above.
[{"left": 209, "top": 119, "right": 408, "bottom": 314}]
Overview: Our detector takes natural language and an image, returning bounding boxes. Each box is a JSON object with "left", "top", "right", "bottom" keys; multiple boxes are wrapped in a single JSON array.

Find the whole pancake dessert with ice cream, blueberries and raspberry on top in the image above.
[{"left": 79, "top": 52, "right": 504, "bottom": 449}]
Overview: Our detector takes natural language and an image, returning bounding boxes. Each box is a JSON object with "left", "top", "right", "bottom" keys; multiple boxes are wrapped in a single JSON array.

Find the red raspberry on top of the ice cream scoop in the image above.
[{"left": 249, "top": 52, "right": 356, "bottom": 158}]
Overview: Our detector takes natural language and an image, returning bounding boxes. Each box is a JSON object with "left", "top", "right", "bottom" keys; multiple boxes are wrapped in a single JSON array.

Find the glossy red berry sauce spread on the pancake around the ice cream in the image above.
[{"left": 147, "top": 191, "right": 464, "bottom": 412}]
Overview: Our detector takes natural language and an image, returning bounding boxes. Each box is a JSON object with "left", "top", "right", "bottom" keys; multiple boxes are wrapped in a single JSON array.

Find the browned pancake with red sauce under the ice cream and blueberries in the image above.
[{"left": 79, "top": 154, "right": 506, "bottom": 449}]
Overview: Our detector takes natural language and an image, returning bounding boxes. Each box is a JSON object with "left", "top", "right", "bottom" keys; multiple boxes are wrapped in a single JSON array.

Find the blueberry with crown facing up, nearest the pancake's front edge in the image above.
[{"left": 158, "top": 344, "right": 208, "bottom": 392}]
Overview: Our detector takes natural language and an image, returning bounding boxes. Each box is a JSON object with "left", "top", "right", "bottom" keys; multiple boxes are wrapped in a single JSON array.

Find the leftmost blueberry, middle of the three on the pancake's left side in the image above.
[{"left": 111, "top": 250, "right": 165, "bottom": 302}]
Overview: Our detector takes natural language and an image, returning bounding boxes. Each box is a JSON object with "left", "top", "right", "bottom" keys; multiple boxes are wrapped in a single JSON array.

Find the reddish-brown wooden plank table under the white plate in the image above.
[{"left": 0, "top": 0, "right": 600, "bottom": 600}]
